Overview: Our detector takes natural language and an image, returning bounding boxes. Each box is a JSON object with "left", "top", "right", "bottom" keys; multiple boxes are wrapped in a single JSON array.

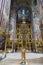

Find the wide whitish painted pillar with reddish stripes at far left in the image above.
[{"left": 0, "top": 0, "right": 11, "bottom": 29}]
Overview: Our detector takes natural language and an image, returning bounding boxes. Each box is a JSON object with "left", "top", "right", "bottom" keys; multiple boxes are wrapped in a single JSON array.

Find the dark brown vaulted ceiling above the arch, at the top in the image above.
[{"left": 11, "top": 0, "right": 37, "bottom": 6}]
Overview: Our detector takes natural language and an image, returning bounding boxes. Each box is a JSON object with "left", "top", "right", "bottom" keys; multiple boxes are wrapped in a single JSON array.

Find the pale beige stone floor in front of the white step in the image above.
[{"left": 0, "top": 58, "right": 43, "bottom": 65}]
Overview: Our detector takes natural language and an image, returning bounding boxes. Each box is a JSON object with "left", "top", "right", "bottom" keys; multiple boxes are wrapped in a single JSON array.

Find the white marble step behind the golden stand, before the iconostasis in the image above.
[{"left": 6, "top": 53, "right": 43, "bottom": 59}]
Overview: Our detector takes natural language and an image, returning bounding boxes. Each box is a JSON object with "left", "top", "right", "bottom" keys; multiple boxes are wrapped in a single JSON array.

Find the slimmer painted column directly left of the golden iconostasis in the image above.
[{"left": 10, "top": 10, "right": 16, "bottom": 49}]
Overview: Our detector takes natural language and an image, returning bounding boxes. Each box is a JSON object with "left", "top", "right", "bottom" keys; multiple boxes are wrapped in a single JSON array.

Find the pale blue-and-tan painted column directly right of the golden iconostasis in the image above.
[{"left": 32, "top": 0, "right": 42, "bottom": 51}]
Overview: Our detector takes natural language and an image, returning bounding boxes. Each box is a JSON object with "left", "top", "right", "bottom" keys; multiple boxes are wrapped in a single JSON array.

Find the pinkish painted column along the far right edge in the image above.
[{"left": 37, "top": 0, "right": 43, "bottom": 38}]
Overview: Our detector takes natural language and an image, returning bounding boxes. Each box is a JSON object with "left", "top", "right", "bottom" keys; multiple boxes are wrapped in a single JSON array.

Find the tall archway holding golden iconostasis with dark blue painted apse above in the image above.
[{"left": 16, "top": 4, "right": 33, "bottom": 52}]
